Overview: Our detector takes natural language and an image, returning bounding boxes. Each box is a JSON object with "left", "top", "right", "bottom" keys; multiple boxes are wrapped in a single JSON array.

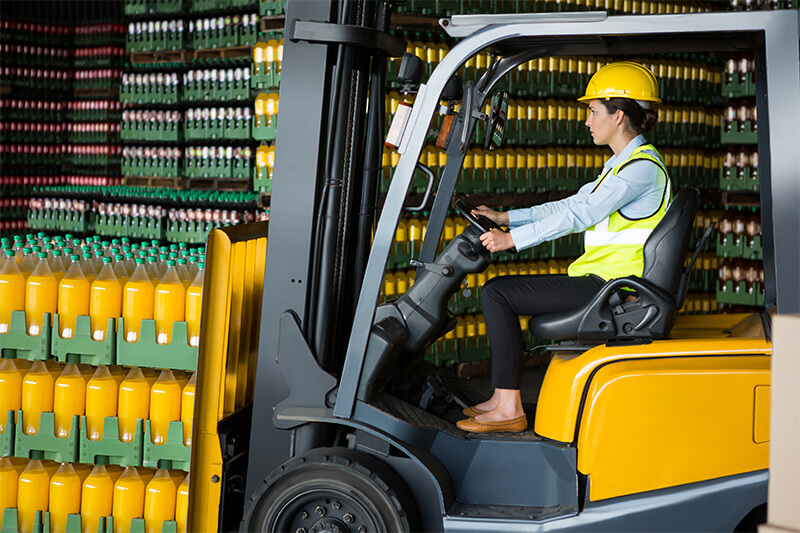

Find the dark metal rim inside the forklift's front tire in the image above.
[{"left": 270, "top": 488, "right": 383, "bottom": 533}]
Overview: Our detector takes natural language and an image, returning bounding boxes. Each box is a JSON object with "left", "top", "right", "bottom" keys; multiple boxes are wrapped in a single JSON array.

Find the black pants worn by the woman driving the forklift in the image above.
[{"left": 481, "top": 274, "right": 605, "bottom": 389}]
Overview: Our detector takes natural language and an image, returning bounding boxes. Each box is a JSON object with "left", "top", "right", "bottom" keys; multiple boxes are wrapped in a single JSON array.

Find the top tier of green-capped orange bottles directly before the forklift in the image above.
[{"left": 0, "top": 233, "right": 209, "bottom": 354}]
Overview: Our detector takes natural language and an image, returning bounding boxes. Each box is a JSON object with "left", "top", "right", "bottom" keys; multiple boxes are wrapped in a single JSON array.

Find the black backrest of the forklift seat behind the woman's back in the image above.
[{"left": 642, "top": 187, "right": 699, "bottom": 297}]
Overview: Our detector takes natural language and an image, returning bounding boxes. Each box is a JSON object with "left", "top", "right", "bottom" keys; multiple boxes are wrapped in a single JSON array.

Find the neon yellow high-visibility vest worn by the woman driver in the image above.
[{"left": 567, "top": 144, "right": 672, "bottom": 280}]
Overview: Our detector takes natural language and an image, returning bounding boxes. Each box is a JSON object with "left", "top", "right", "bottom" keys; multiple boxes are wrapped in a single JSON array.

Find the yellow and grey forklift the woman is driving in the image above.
[{"left": 189, "top": 0, "right": 800, "bottom": 533}]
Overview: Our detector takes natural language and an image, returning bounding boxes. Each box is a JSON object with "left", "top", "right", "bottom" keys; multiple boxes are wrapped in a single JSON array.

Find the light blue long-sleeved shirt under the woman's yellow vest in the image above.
[{"left": 508, "top": 135, "right": 664, "bottom": 250}]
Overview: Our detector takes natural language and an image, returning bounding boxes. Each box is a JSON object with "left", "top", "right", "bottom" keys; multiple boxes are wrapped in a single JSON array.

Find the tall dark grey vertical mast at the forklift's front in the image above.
[{"left": 246, "top": 0, "right": 405, "bottom": 512}]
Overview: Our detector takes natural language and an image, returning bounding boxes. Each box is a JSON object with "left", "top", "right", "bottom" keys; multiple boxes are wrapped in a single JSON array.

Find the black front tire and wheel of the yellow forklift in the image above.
[{"left": 242, "top": 448, "right": 418, "bottom": 533}]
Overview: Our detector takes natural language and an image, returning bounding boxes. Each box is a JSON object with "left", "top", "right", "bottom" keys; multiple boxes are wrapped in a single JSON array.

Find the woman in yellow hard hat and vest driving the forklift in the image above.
[{"left": 458, "top": 61, "right": 671, "bottom": 433}]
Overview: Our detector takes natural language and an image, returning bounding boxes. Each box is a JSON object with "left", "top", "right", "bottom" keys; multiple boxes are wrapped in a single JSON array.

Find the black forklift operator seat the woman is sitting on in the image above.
[{"left": 529, "top": 188, "right": 700, "bottom": 343}]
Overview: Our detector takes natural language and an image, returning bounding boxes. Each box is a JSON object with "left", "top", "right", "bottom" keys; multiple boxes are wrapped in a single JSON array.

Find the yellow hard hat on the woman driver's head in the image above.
[{"left": 578, "top": 61, "right": 661, "bottom": 104}]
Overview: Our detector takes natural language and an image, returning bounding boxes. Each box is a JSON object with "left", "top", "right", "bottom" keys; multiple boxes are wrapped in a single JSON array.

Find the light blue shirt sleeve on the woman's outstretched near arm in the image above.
[{"left": 508, "top": 161, "right": 658, "bottom": 250}]
